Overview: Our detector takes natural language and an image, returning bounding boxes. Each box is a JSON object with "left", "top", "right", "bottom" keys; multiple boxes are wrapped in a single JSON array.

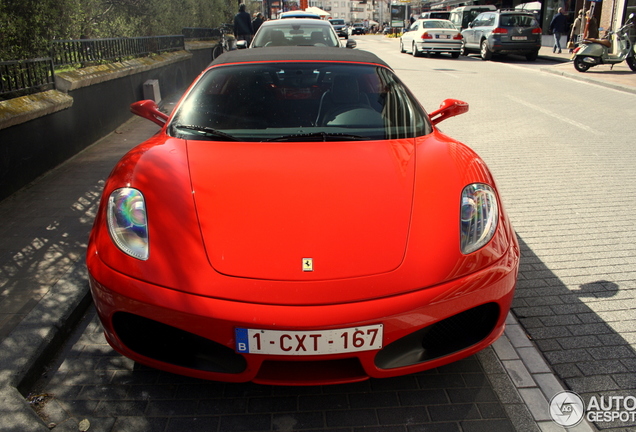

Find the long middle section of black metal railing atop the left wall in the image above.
[{"left": 51, "top": 35, "right": 185, "bottom": 66}]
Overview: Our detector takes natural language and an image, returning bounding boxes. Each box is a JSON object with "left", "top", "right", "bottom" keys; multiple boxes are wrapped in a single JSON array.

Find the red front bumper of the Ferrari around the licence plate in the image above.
[{"left": 89, "top": 241, "right": 518, "bottom": 385}]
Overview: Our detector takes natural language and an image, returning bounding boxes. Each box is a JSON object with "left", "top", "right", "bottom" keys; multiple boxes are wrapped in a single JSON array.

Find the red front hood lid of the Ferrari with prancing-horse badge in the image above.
[{"left": 187, "top": 140, "right": 415, "bottom": 281}]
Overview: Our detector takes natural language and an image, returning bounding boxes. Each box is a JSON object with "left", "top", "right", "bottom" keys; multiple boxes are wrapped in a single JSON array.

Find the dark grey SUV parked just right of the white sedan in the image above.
[{"left": 462, "top": 11, "right": 542, "bottom": 61}]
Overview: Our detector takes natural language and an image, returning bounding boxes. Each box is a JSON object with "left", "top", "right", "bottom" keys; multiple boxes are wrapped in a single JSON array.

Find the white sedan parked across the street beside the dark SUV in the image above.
[{"left": 400, "top": 19, "right": 462, "bottom": 58}]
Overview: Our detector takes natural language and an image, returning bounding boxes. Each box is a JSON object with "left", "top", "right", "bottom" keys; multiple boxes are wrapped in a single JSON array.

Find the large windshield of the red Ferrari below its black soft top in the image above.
[{"left": 168, "top": 62, "right": 431, "bottom": 141}]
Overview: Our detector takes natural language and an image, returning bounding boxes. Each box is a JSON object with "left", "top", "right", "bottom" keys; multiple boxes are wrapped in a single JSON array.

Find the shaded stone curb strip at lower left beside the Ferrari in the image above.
[{"left": 0, "top": 261, "right": 91, "bottom": 432}]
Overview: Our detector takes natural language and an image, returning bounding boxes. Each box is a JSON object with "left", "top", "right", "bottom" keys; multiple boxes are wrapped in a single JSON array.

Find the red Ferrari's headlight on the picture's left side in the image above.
[{"left": 106, "top": 188, "right": 148, "bottom": 260}]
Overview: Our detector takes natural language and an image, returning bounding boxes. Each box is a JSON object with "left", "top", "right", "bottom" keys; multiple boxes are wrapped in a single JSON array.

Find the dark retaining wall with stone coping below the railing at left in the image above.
[{"left": 0, "top": 42, "right": 214, "bottom": 201}]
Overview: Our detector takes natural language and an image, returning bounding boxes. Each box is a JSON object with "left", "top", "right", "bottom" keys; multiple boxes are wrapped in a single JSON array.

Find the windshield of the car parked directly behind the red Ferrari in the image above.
[{"left": 250, "top": 22, "right": 340, "bottom": 48}]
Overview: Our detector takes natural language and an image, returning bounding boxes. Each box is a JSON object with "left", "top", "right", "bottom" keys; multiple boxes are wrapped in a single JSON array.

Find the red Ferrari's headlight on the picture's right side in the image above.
[{"left": 460, "top": 183, "right": 499, "bottom": 254}]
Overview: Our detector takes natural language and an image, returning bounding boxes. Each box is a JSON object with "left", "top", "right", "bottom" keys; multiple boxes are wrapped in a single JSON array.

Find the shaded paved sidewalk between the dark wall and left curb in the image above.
[{"left": 0, "top": 118, "right": 163, "bottom": 342}]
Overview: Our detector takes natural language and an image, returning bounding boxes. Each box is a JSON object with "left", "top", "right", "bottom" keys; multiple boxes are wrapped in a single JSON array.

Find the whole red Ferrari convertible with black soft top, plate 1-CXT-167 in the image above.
[{"left": 87, "top": 47, "right": 519, "bottom": 385}]
